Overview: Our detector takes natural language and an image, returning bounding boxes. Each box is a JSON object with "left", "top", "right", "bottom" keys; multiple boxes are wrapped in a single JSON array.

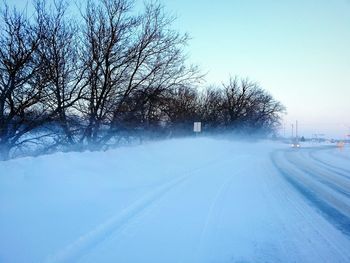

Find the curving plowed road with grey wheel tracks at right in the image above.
[{"left": 272, "top": 147, "right": 350, "bottom": 236}]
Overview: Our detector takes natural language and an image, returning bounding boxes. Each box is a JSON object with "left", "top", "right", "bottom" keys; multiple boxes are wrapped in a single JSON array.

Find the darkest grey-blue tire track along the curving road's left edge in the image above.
[{"left": 271, "top": 151, "right": 350, "bottom": 236}]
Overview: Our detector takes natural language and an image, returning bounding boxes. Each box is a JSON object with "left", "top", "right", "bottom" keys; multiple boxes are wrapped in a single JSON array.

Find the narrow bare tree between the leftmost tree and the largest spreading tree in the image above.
[{"left": 36, "top": 1, "right": 84, "bottom": 145}]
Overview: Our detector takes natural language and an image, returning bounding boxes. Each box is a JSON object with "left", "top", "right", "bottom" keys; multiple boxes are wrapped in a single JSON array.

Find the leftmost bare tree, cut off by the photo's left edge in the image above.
[{"left": 0, "top": 5, "right": 45, "bottom": 159}]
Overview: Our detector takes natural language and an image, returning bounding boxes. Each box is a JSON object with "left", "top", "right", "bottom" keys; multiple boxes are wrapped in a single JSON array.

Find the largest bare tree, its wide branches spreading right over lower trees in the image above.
[{"left": 78, "top": 0, "right": 200, "bottom": 148}]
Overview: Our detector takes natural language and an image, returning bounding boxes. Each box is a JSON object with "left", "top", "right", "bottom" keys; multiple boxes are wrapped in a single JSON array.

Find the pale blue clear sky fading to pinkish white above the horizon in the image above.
[{"left": 4, "top": 0, "right": 350, "bottom": 137}]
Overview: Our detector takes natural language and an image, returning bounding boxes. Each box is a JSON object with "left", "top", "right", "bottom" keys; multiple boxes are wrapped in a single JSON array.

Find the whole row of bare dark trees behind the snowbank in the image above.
[{"left": 0, "top": 0, "right": 284, "bottom": 159}]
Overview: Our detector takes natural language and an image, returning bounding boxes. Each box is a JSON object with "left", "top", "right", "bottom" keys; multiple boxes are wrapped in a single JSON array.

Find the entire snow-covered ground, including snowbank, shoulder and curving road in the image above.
[{"left": 0, "top": 138, "right": 350, "bottom": 263}]
